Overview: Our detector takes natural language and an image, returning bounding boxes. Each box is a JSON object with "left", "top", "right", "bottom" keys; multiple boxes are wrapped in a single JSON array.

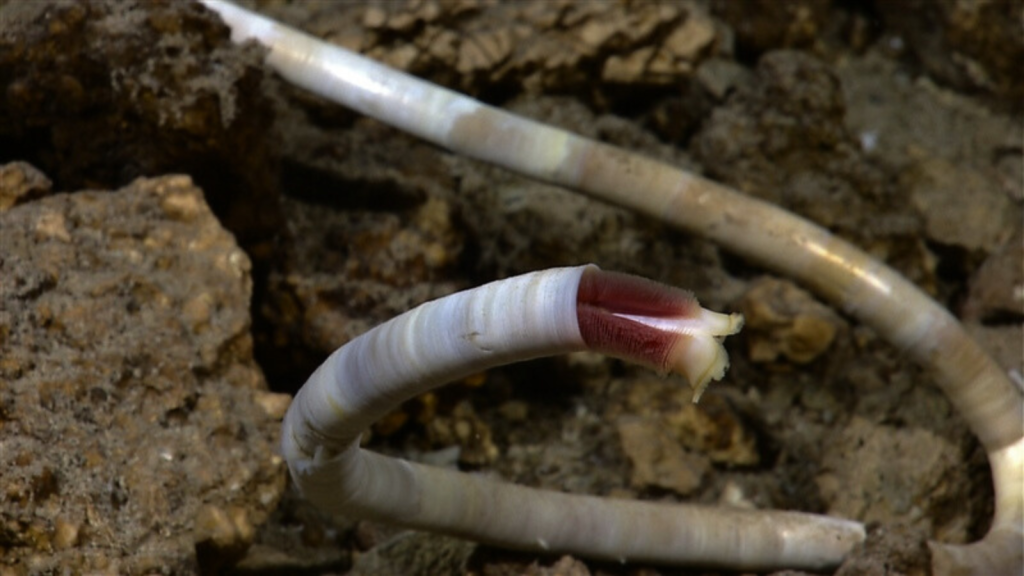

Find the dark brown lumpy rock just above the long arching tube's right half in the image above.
[{"left": 693, "top": 51, "right": 925, "bottom": 249}]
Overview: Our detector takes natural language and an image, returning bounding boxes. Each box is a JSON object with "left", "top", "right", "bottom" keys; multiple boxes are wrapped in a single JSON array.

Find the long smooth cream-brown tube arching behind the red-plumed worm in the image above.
[{"left": 202, "top": 0, "right": 1024, "bottom": 576}]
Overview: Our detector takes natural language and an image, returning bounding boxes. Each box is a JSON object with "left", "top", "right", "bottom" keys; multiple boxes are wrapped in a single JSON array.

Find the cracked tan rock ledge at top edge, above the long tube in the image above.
[{"left": 260, "top": 0, "right": 731, "bottom": 99}]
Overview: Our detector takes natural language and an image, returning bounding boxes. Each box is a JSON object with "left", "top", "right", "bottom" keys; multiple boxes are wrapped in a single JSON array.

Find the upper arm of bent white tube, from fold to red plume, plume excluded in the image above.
[{"left": 285, "top": 266, "right": 586, "bottom": 461}]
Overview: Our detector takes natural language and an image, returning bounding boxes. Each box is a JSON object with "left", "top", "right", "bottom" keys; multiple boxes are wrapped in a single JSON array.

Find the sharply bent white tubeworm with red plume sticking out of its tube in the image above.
[{"left": 284, "top": 266, "right": 864, "bottom": 569}]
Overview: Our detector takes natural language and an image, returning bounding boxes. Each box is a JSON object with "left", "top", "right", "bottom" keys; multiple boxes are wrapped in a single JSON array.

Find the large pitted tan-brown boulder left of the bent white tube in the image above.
[{"left": 0, "top": 172, "right": 285, "bottom": 574}]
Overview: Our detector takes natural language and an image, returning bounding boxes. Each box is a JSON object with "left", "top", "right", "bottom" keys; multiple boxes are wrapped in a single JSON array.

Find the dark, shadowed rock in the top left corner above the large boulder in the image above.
[{"left": 0, "top": 0, "right": 280, "bottom": 247}]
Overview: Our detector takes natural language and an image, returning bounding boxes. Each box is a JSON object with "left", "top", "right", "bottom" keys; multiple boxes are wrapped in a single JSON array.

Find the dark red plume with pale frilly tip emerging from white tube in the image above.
[{"left": 577, "top": 269, "right": 743, "bottom": 402}]
